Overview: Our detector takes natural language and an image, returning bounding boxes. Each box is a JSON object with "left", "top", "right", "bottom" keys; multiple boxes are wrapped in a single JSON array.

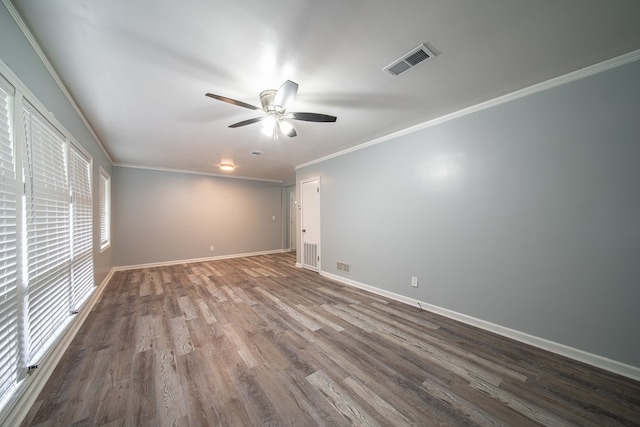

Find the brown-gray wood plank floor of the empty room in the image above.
[{"left": 23, "top": 254, "right": 640, "bottom": 426}]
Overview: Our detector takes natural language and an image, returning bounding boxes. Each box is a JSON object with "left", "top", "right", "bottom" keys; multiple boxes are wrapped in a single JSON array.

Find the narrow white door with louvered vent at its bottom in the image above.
[{"left": 300, "top": 178, "right": 320, "bottom": 271}]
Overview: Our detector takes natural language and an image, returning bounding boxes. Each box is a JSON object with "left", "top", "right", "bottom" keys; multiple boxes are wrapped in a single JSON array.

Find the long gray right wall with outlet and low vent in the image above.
[{"left": 296, "top": 61, "right": 640, "bottom": 367}]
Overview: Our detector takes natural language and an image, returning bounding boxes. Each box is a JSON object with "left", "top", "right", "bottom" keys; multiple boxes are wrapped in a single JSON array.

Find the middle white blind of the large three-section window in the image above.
[{"left": 23, "top": 104, "right": 71, "bottom": 361}]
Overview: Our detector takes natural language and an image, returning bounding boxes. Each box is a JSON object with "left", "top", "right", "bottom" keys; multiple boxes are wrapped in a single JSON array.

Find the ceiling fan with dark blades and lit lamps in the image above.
[{"left": 206, "top": 80, "right": 337, "bottom": 138}]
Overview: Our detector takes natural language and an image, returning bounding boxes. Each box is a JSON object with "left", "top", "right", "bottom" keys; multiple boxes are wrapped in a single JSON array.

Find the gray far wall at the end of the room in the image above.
[{"left": 112, "top": 167, "right": 283, "bottom": 266}]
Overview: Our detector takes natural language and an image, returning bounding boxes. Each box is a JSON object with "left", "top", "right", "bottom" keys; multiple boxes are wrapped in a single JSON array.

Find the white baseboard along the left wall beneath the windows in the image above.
[{"left": 0, "top": 269, "right": 114, "bottom": 426}]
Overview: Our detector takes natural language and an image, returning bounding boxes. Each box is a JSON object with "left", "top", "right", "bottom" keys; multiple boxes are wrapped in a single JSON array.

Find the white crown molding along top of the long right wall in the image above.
[{"left": 295, "top": 49, "right": 640, "bottom": 170}]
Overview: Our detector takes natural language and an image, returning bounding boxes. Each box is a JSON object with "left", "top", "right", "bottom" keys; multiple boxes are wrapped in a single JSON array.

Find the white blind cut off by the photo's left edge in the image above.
[{"left": 0, "top": 77, "right": 19, "bottom": 401}]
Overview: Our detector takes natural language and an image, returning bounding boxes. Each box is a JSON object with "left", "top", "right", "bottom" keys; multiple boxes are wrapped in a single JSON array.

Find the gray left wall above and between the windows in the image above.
[{"left": 0, "top": 4, "right": 113, "bottom": 284}]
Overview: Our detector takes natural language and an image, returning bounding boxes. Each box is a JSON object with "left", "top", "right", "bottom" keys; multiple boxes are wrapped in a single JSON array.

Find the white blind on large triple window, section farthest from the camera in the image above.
[{"left": 69, "top": 146, "right": 93, "bottom": 311}]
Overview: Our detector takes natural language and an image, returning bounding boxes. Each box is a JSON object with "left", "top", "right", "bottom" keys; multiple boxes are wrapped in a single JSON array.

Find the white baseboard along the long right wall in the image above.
[{"left": 320, "top": 271, "right": 640, "bottom": 381}]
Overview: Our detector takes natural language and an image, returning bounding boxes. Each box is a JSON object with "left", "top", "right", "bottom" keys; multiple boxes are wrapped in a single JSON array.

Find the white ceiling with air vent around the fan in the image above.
[{"left": 12, "top": 0, "right": 640, "bottom": 182}]
